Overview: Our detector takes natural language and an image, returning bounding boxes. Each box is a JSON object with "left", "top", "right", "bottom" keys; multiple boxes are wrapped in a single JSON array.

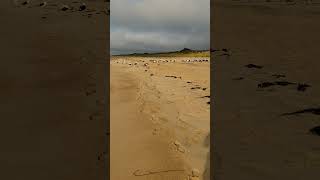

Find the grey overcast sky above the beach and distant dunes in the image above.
[{"left": 110, "top": 0, "right": 210, "bottom": 54}]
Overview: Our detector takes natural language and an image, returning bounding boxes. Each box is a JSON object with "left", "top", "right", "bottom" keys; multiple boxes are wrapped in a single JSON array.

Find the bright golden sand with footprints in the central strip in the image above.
[{"left": 110, "top": 57, "right": 210, "bottom": 180}]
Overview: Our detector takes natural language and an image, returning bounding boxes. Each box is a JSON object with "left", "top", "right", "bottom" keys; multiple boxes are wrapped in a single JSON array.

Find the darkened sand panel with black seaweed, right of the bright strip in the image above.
[{"left": 211, "top": 1, "right": 320, "bottom": 180}]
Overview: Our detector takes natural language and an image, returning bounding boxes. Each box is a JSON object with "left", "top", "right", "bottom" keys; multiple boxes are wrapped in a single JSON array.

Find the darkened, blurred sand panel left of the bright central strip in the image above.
[{"left": 0, "top": 0, "right": 109, "bottom": 180}]
